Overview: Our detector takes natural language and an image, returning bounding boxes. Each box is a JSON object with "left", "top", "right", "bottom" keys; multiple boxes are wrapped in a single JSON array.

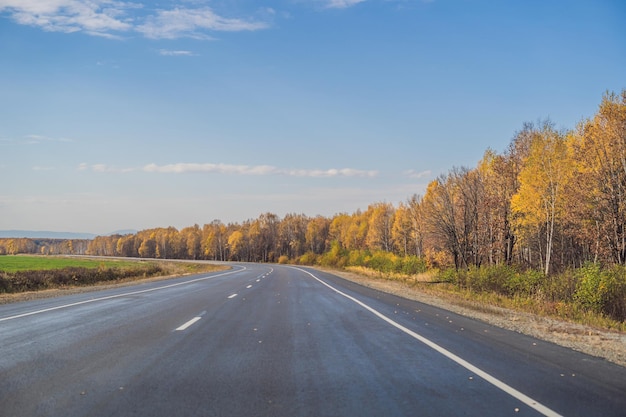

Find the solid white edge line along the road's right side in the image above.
[{"left": 291, "top": 267, "right": 563, "bottom": 417}]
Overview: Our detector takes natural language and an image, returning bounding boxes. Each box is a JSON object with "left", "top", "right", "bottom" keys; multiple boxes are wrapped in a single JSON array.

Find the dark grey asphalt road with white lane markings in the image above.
[{"left": 0, "top": 264, "right": 626, "bottom": 417}]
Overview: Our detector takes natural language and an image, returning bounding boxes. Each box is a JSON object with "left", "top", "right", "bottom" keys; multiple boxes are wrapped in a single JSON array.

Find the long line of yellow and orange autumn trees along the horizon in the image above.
[{"left": 0, "top": 90, "right": 626, "bottom": 275}]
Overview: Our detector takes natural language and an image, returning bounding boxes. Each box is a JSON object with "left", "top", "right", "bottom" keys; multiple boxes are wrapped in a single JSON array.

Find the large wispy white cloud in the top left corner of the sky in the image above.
[{"left": 0, "top": 0, "right": 269, "bottom": 39}]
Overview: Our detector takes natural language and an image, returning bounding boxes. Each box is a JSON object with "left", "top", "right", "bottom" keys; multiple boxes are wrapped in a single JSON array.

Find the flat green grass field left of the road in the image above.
[{"left": 0, "top": 255, "right": 151, "bottom": 272}]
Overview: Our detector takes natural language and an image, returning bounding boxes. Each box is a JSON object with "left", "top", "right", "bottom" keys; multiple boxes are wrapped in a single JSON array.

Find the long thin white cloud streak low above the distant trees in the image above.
[{"left": 78, "top": 163, "right": 378, "bottom": 178}]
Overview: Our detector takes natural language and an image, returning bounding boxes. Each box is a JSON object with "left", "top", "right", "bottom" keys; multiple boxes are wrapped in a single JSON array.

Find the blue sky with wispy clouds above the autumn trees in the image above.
[{"left": 0, "top": 0, "right": 626, "bottom": 233}]
